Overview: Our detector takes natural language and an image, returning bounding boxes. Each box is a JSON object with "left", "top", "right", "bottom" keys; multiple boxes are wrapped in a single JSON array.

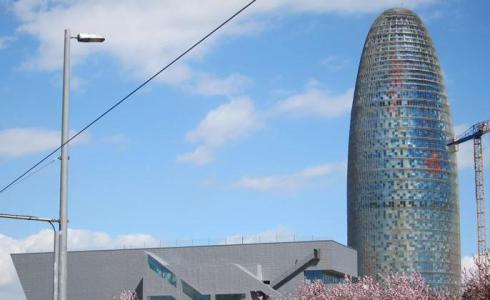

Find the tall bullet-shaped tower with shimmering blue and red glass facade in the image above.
[{"left": 347, "top": 9, "right": 461, "bottom": 291}]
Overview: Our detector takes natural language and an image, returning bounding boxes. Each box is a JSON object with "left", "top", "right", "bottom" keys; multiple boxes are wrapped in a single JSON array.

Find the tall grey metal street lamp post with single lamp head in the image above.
[{"left": 58, "top": 29, "right": 105, "bottom": 300}]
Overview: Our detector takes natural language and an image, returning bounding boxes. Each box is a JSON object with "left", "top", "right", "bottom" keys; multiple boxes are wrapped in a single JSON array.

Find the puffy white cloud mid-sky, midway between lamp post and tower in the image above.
[{"left": 177, "top": 97, "right": 261, "bottom": 164}]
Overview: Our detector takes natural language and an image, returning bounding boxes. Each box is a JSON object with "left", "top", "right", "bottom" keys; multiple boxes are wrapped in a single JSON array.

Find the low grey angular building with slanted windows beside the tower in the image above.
[{"left": 12, "top": 241, "right": 357, "bottom": 300}]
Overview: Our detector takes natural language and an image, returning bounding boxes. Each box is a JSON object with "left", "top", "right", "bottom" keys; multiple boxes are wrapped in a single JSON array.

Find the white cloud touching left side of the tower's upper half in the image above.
[{"left": 276, "top": 83, "right": 354, "bottom": 118}]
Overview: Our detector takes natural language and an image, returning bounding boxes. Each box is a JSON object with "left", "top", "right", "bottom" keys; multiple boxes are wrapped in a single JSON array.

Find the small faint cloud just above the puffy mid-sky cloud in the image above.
[{"left": 195, "top": 73, "right": 251, "bottom": 96}]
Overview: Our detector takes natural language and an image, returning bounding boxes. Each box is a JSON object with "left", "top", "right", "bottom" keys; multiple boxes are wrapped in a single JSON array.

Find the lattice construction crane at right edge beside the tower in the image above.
[{"left": 447, "top": 120, "right": 490, "bottom": 261}]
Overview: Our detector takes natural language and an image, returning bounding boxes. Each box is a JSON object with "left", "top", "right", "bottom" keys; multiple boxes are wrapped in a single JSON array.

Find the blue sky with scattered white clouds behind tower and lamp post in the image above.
[{"left": 0, "top": 0, "right": 490, "bottom": 299}]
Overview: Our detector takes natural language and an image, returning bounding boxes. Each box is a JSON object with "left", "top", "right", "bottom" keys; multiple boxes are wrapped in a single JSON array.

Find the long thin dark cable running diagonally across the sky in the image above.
[{"left": 0, "top": 0, "right": 257, "bottom": 194}]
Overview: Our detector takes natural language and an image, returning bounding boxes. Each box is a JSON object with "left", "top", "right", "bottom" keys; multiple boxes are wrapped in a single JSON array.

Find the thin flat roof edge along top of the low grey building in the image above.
[{"left": 10, "top": 240, "right": 356, "bottom": 256}]
